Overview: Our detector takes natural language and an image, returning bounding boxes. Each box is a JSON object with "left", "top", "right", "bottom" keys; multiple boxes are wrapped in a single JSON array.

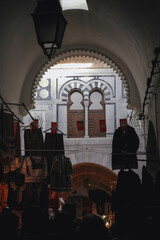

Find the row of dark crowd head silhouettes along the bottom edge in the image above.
[{"left": 0, "top": 202, "right": 160, "bottom": 240}]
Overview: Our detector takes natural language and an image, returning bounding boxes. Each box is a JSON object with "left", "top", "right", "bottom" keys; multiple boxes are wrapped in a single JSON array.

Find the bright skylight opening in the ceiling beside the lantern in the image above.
[{"left": 60, "top": 0, "right": 88, "bottom": 11}]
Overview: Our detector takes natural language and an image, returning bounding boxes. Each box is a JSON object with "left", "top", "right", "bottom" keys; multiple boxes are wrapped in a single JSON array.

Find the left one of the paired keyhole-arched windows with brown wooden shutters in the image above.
[{"left": 67, "top": 90, "right": 85, "bottom": 138}]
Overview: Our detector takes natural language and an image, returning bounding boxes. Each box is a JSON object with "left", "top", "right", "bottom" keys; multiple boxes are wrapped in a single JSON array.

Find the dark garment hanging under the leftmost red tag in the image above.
[{"left": 24, "top": 128, "right": 44, "bottom": 156}]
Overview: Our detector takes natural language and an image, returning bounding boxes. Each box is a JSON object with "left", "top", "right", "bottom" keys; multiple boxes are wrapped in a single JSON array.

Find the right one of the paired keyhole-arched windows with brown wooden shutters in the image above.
[{"left": 88, "top": 89, "right": 106, "bottom": 137}]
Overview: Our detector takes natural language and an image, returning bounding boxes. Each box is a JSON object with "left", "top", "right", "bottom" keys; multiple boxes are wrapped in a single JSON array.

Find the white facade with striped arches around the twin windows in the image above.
[{"left": 22, "top": 63, "right": 145, "bottom": 177}]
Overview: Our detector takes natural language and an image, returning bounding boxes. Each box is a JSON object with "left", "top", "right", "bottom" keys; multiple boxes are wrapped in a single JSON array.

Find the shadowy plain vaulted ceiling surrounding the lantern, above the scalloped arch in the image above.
[{"left": 0, "top": 0, "right": 160, "bottom": 116}]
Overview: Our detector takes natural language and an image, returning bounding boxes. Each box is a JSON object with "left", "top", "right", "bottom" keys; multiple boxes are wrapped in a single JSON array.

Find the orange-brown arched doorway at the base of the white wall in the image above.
[{"left": 62, "top": 162, "right": 117, "bottom": 221}]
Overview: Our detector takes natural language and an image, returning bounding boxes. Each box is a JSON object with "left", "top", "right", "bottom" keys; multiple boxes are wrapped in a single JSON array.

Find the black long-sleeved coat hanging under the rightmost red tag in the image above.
[{"left": 112, "top": 126, "right": 139, "bottom": 169}]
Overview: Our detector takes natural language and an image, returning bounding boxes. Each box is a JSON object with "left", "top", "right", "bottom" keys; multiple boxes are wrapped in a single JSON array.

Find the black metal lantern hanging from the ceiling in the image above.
[{"left": 31, "top": 0, "right": 67, "bottom": 59}]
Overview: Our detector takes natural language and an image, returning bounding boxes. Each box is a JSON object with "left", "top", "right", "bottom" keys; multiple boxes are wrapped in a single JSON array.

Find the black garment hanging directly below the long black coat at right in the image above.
[{"left": 111, "top": 169, "right": 143, "bottom": 227}]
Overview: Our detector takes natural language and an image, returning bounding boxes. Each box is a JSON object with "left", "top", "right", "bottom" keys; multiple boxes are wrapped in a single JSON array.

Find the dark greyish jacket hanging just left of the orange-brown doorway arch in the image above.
[{"left": 50, "top": 155, "right": 73, "bottom": 192}]
